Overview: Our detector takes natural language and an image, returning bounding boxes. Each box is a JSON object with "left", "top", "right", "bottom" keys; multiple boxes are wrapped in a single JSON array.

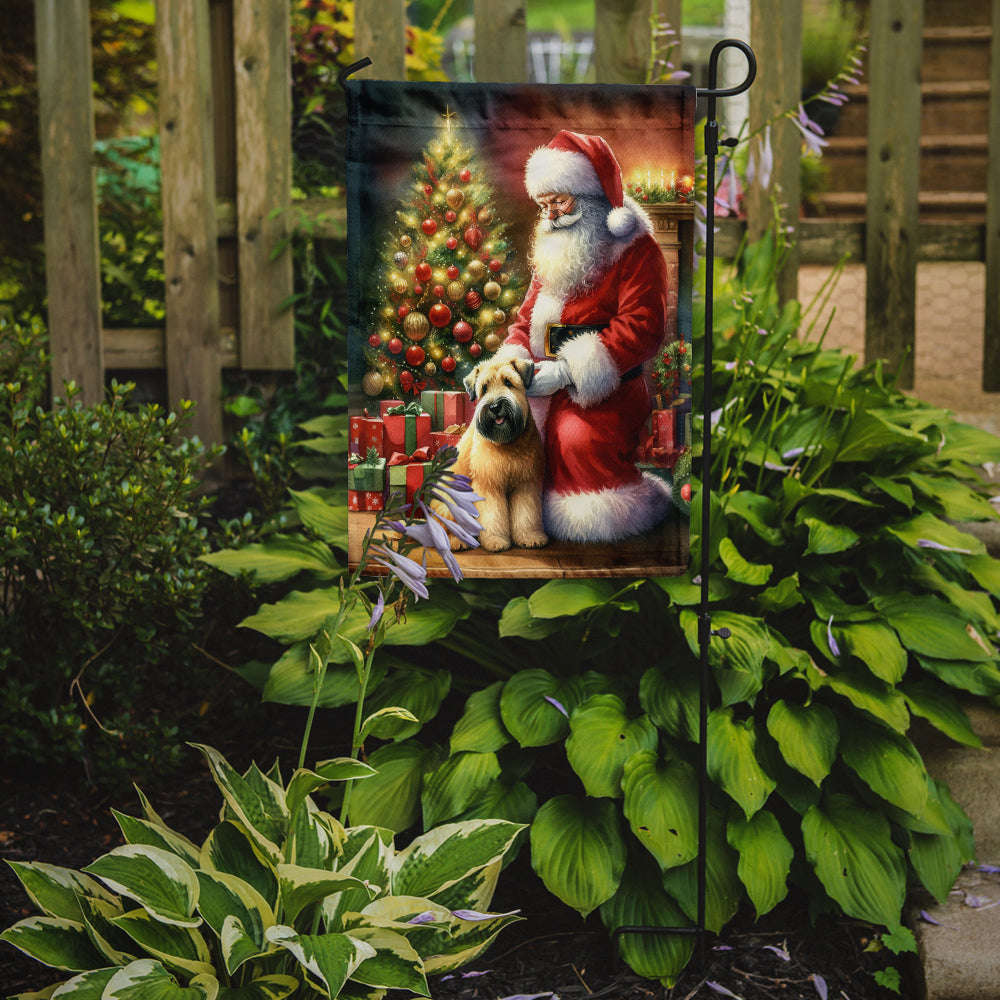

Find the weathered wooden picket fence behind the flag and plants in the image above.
[{"left": 35, "top": 0, "right": 1000, "bottom": 442}]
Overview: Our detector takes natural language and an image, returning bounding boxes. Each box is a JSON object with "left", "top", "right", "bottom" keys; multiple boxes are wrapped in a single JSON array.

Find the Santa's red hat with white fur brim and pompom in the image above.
[{"left": 524, "top": 129, "right": 641, "bottom": 236}]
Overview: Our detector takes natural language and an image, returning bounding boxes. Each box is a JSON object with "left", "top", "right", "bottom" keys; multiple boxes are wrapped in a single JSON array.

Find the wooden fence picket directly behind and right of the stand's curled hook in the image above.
[{"left": 746, "top": 0, "right": 802, "bottom": 302}]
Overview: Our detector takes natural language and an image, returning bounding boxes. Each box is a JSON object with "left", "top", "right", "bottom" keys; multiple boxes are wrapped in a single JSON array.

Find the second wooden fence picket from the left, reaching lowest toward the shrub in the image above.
[{"left": 156, "top": 0, "right": 222, "bottom": 443}]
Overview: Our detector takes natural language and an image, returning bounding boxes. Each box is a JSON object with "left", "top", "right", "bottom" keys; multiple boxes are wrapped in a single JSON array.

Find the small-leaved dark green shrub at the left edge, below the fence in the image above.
[{"left": 0, "top": 321, "right": 220, "bottom": 777}]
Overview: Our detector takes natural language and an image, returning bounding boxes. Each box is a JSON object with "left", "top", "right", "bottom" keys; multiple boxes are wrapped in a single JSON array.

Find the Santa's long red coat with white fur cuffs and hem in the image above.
[{"left": 501, "top": 203, "right": 670, "bottom": 542}]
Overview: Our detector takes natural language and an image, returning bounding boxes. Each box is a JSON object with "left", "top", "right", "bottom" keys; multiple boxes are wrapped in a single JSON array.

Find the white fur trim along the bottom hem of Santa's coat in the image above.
[{"left": 543, "top": 472, "right": 671, "bottom": 542}]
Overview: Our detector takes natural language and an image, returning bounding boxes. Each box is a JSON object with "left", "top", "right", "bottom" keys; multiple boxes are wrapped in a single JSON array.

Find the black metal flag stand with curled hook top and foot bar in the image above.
[{"left": 613, "top": 38, "right": 757, "bottom": 970}]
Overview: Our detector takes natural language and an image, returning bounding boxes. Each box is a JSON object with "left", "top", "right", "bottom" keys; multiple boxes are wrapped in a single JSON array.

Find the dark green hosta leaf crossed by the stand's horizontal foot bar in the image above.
[{"left": 601, "top": 853, "right": 694, "bottom": 986}]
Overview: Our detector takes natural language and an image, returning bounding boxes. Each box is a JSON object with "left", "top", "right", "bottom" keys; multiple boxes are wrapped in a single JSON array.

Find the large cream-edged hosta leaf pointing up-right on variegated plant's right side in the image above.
[{"left": 392, "top": 819, "right": 523, "bottom": 899}]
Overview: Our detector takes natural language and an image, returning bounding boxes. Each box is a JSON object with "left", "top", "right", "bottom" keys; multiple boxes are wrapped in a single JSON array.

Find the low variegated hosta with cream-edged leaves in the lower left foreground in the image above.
[{"left": 0, "top": 746, "right": 521, "bottom": 1000}]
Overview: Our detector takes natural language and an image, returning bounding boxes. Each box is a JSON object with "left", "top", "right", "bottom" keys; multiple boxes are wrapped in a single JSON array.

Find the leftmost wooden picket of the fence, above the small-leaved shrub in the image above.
[{"left": 35, "top": 0, "right": 104, "bottom": 405}]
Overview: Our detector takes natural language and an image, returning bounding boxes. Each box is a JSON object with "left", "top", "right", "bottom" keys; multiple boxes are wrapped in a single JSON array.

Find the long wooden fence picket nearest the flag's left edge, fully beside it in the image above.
[{"left": 233, "top": 0, "right": 295, "bottom": 369}]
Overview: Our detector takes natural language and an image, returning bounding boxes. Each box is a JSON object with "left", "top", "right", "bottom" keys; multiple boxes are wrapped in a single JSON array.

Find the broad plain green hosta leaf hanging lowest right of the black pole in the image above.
[{"left": 802, "top": 794, "right": 906, "bottom": 925}]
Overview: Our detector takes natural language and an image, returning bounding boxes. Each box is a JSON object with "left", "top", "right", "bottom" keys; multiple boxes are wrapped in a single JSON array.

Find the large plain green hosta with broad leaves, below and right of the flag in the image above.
[{"left": 207, "top": 232, "right": 1000, "bottom": 982}]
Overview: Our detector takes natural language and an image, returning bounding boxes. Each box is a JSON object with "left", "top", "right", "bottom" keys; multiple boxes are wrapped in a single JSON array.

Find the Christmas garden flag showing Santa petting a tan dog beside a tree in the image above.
[{"left": 347, "top": 80, "right": 695, "bottom": 577}]
